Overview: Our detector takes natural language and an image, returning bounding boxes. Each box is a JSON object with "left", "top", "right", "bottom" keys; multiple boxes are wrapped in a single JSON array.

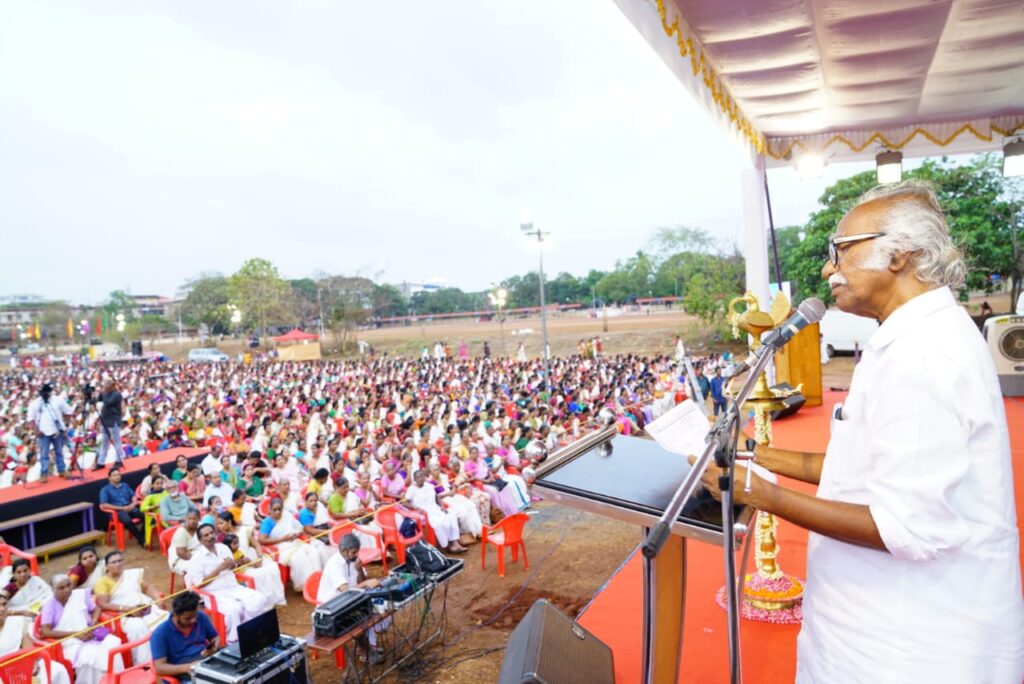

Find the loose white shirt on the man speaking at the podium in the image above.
[{"left": 797, "top": 288, "right": 1024, "bottom": 684}]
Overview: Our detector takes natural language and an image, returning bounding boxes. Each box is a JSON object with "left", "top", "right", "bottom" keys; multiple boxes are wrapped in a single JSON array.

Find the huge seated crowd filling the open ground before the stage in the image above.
[{"left": 0, "top": 353, "right": 712, "bottom": 684}]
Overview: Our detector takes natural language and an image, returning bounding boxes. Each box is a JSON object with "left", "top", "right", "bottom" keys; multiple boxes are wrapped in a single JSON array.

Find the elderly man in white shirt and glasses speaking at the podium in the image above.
[{"left": 703, "top": 182, "right": 1024, "bottom": 684}]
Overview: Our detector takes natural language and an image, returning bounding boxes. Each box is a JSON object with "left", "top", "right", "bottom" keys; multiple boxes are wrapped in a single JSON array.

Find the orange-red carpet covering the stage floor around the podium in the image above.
[{"left": 580, "top": 392, "right": 1024, "bottom": 684}]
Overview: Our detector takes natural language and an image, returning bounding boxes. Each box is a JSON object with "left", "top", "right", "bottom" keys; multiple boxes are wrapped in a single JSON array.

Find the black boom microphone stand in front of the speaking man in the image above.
[{"left": 641, "top": 345, "right": 775, "bottom": 684}]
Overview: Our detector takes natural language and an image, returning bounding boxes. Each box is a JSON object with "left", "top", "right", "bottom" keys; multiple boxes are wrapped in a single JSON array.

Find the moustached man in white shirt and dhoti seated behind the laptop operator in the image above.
[{"left": 185, "top": 525, "right": 268, "bottom": 643}]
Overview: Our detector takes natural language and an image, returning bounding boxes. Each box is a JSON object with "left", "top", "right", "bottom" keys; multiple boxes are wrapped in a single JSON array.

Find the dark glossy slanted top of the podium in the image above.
[{"left": 534, "top": 435, "right": 753, "bottom": 545}]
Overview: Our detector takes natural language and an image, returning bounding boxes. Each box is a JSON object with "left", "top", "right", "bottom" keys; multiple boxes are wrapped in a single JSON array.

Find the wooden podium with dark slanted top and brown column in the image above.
[{"left": 534, "top": 426, "right": 755, "bottom": 683}]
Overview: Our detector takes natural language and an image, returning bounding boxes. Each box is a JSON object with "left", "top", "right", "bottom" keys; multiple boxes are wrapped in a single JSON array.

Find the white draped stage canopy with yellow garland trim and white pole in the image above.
[{"left": 615, "top": 0, "right": 1024, "bottom": 305}]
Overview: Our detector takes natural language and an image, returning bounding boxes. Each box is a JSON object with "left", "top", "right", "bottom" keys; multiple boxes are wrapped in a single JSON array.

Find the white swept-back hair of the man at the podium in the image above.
[{"left": 856, "top": 180, "right": 967, "bottom": 290}]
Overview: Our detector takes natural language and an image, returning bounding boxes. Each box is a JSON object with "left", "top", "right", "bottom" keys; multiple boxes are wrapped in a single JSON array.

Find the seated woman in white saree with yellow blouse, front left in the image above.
[{"left": 92, "top": 551, "right": 167, "bottom": 662}]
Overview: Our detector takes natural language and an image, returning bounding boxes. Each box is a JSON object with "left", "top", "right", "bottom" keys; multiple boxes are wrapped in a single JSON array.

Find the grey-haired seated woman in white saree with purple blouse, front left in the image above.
[{"left": 39, "top": 573, "right": 124, "bottom": 684}]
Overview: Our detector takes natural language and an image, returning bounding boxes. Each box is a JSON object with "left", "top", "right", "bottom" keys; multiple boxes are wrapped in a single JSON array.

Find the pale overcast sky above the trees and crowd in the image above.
[{"left": 0, "top": 0, "right": 866, "bottom": 303}]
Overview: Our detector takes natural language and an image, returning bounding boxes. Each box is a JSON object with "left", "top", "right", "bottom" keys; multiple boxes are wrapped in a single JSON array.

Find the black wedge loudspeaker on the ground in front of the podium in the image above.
[{"left": 498, "top": 599, "right": 615, "bottom": 684}]
